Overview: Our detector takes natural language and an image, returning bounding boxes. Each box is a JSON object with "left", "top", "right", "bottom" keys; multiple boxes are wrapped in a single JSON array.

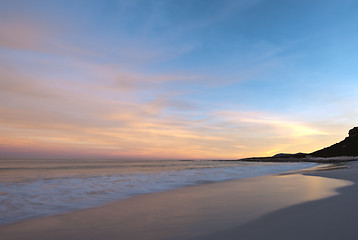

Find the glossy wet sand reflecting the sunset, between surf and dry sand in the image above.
[{"left": 0, "top": 162, "right": 352, "bottom": 239}]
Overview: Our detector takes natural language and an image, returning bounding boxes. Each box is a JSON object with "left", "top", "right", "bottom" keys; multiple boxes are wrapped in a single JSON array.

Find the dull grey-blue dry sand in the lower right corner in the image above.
[{"left": 200, "top": 162, "right": 358, "bottom": 240}]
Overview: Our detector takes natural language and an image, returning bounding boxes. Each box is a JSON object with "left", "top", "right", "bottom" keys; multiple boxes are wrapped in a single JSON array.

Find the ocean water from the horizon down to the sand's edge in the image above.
[{"left": 0, "top": 159, "right": 316, "bottom": 225}]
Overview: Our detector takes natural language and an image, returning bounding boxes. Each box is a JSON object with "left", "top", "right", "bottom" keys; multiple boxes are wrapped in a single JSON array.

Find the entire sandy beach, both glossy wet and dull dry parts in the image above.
[{"left": 0, "top": 163, "right": 358, "bottom": 240}]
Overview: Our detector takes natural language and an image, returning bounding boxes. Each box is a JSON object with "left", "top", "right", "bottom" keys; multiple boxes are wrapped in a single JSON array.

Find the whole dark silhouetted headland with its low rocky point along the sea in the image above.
[{"left": 240, "top": 127, "right": 358, "bottom": 163}]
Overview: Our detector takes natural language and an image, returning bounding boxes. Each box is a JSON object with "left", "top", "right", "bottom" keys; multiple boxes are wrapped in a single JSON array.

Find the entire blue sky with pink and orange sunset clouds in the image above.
[{"left": 0, "top": 0, "right": 358, "bottom": 159}]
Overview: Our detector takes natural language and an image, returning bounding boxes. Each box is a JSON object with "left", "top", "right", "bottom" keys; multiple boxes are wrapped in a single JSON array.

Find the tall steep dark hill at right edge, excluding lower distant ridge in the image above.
[{"left": 309, "top": 127, "right": 358, "bottom": 157}]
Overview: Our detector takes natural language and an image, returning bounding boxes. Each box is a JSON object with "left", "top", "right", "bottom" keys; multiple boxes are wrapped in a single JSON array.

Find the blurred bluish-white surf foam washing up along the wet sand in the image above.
[{"left": 0, "top": 161, "right": 317, "bottom": 226}]
